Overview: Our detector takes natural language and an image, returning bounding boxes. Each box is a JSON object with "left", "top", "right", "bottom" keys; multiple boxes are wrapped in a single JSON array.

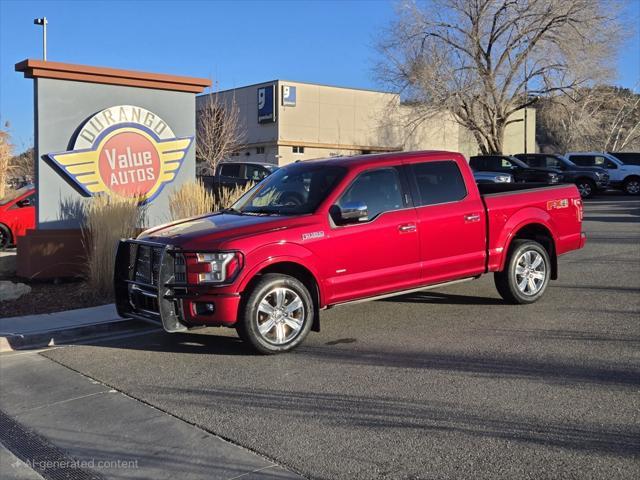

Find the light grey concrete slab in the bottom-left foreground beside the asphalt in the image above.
[{"left": 0, "top": 347, "right": 301, "bottom": 480}]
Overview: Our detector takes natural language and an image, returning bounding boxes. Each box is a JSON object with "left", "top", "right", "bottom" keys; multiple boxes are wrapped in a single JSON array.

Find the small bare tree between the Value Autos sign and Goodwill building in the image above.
[{"left": 196, "top": 88, "right": 246, "bottom": 171}]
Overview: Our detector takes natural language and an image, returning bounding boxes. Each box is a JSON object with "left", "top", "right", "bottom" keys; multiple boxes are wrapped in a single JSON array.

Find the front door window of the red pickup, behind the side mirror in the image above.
[{"left": 338, "top": 168, "right": 404, "bottom": 220}]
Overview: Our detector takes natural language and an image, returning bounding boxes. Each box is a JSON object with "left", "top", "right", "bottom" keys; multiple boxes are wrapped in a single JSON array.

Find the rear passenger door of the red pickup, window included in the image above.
[{"left": 407, "top": 159, "right": 486, "bottom": 284}]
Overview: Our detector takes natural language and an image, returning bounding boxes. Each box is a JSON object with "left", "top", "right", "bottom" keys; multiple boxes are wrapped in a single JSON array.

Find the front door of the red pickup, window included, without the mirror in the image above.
[{"left": 323, "top": 167, "right": 420, "bottom": 303}]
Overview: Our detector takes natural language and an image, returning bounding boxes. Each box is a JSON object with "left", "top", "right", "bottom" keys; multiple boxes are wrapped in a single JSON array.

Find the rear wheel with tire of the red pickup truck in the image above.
[{"left": 493, "top": 240, "right": 551, "bottom": 305}]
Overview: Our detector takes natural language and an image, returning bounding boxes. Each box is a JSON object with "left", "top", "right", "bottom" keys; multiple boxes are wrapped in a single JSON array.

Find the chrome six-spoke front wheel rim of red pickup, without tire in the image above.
[{"left": 256, "top": 287, "right": 306, "bottom": 345}]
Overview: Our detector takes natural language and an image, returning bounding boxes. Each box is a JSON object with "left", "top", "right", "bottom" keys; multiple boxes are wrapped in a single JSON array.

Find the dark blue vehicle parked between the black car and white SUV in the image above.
[{"left": 515, "top": 153, "right": 609, "bottom": 198}]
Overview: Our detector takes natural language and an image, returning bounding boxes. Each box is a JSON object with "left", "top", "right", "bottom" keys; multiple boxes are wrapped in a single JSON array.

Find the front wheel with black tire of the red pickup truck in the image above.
[{"left": 236, "top": 273, "right": 315, "bottom": 354}]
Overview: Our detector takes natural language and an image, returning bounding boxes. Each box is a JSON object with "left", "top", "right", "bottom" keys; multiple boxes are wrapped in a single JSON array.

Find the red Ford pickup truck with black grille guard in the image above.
[{"left": 115, "top": 152, "right": 585, "bottom": 353}]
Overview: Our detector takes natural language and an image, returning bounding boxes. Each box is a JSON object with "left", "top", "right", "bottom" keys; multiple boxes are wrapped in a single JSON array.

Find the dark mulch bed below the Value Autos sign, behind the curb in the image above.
[{"left": 0, "top": 277, "right": 113, "bottom": 318}]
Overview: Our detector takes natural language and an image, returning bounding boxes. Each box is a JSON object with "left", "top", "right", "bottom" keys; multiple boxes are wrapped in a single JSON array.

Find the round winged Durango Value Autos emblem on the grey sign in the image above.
[{"left": 47, "top": 105, "right": 193, "bottom": 203}]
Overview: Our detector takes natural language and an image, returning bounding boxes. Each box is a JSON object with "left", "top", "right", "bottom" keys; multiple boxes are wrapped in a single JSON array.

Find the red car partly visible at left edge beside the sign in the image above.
[{"left": 0, "top": 185, "right": 36, "bottom": 250}]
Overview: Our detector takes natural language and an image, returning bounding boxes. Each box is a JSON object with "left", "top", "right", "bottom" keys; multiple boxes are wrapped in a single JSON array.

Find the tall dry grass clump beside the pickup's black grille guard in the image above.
[{"left": 82, "top": 195, "right": 145, "bottom": 299}]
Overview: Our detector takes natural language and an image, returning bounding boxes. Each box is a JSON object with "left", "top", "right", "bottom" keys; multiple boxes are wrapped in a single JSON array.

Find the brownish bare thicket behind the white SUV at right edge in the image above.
[{"left": 537, "top": 86, "right": 640, "bottom": 152}]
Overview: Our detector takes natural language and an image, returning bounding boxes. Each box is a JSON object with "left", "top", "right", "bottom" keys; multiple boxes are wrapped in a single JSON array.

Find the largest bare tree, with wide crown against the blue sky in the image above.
[{"left": 377, "top": 0, "right": 621, "bottom": 154}]
